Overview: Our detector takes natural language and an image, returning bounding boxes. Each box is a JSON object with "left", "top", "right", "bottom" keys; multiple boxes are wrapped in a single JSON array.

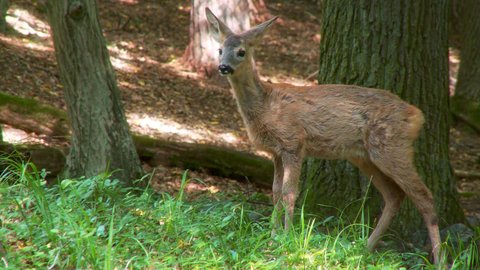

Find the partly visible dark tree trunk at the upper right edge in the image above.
[{"left": 454, "top": 0, "right": 480, "bottom": 102}]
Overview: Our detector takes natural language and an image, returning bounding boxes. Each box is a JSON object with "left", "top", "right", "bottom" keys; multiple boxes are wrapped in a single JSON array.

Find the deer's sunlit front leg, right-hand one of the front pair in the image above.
[{"left": 282, "top": 154, "right": 302, "bottom": 230}]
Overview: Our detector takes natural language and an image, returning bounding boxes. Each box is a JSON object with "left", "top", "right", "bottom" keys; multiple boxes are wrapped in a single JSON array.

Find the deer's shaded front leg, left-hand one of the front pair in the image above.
[{"left": 272, "top": 155, "right": 283, "bottom": 236}]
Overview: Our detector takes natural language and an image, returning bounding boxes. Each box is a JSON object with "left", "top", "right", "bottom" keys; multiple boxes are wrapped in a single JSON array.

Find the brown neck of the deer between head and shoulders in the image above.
[{"left": 228, "top": 57, "right": 266, "bottom": 124}]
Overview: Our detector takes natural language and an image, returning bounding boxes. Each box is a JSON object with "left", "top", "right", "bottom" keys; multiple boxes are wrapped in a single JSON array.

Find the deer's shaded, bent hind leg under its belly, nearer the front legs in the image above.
[{"left": 350, "top": 159, "right": 405, "bottom": 251}]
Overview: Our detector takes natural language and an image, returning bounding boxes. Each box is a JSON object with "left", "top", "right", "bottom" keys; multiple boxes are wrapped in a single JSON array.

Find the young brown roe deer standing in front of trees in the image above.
[{"left": 206, "top": 8, "right": 440, "bottom": 263}]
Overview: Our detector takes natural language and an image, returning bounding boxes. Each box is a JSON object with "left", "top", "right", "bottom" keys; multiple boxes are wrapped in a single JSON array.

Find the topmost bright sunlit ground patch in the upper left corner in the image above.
[{"left": 6, "top": 8, "right": 50, "bottom": 39}]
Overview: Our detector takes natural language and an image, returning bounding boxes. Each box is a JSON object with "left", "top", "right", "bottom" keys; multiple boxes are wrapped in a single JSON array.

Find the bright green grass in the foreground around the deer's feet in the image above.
[{"left": 0, "top": 158, "right": 478, "bottom": 269}]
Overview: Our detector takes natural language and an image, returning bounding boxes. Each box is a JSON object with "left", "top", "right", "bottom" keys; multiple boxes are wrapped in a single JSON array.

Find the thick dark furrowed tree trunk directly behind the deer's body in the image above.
[{"left": 303, "top": 0, "right": 463, "bottom": 244}]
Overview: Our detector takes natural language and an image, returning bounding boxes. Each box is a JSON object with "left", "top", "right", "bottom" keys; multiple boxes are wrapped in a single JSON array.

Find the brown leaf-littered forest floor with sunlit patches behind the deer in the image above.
[{"left": 0, "top": 0, "right": 480, "bottom": 224}]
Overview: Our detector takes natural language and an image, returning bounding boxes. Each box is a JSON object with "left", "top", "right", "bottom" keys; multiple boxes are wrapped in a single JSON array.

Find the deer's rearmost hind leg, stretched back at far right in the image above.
[{"left": 370, "top": 143, "right": 441, "bottom": 263}]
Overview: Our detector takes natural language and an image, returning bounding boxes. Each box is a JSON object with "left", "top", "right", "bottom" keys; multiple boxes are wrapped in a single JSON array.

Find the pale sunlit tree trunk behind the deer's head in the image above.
[{"left": 183, "top": 0, "right": 250, "bottom": 77}]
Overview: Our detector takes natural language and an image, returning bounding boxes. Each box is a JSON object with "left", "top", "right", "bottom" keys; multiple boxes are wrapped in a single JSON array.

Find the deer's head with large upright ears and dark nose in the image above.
[{"left": 205, "top": 8, "right": 278, "bottom": 76}]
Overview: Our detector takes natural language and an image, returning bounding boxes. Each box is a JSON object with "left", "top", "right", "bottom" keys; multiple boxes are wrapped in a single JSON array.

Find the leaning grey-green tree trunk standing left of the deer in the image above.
[{"left": 47, "top": 0, "right": 142, "bottom": 184}]
